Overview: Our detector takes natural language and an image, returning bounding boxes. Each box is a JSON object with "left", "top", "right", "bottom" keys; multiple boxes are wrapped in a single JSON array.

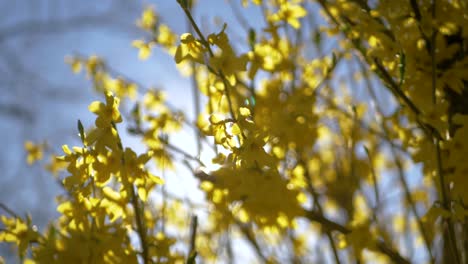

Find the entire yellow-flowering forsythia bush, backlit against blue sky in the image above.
[{"left": 0, "top": 0, "right": 468, "bottom": 263}]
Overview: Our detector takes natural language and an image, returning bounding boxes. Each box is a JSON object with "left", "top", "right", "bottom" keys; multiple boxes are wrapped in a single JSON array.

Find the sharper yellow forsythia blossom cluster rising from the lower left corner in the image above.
[{"left": 4, "top": 92, "right": 188, "bottom": 263}]
